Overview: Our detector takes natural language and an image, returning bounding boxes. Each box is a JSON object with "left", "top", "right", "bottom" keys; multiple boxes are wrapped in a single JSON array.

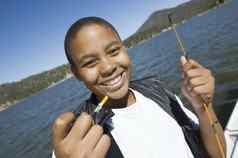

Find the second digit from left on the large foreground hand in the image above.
[{"left": 67, "top": 112, "right": 92, "bottom": 141}]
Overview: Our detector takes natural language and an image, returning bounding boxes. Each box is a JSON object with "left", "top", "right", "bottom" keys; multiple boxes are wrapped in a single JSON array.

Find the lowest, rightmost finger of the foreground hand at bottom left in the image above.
[{"left": 93, "top": 134, "right": 111, "bottom": 157}]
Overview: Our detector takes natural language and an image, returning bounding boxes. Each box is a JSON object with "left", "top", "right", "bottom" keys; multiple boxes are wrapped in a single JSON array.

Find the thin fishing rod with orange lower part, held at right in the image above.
[{"left": 168, "top": 13, "right": 226, "bottom": 158}]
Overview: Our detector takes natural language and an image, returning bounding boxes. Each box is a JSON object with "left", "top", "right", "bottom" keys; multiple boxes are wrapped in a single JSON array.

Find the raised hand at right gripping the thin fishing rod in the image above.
[{"left": 181, "top": 56, "right": 215, "bottom": 112}]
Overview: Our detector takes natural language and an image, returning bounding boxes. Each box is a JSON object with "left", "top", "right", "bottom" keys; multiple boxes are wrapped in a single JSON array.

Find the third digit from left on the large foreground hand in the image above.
[{"left": 83, "top": 125, "right": 103, "bottom": 150}]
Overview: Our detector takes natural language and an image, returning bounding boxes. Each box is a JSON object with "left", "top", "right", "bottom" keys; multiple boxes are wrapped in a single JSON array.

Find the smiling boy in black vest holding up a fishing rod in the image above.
[{"left": 53, "top": 17, "right": 225, "bottom": 158}]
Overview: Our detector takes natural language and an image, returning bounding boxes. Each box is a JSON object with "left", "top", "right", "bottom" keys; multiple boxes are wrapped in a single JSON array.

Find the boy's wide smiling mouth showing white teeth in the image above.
[{"left": 101, "top": 71, "right": 126, "bottom": 91}]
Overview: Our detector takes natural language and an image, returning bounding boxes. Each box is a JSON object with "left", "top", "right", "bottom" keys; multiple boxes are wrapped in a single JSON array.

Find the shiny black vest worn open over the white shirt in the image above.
[{"left": 74, "top": 76, "right": 209, "bottom": 158}]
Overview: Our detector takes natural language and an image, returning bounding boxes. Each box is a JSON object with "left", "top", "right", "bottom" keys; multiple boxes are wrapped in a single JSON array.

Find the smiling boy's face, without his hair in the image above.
[{"left": 71, "top": 24, "right": 131, "bottom": 99}]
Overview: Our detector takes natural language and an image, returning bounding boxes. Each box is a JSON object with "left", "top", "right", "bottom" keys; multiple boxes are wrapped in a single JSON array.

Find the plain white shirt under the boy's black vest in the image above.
[{"left": 111, "top": 90, "right": 198, "bottom": 158}]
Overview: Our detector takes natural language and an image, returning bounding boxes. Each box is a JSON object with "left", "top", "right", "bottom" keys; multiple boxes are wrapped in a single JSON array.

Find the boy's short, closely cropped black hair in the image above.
[{"left": 64, "top": 16, "right": 121, "bottom": 67}]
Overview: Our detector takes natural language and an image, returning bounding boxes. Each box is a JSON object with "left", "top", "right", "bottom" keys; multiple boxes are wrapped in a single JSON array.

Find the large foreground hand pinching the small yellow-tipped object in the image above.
[{"left": 53, "top": 112, "right": 111, "bottom": 158}]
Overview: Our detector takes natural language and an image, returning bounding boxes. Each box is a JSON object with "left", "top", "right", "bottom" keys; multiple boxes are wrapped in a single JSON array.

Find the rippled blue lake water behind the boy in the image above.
[{"left": 0, "top": 0, "right": 238, "bottom": 158}]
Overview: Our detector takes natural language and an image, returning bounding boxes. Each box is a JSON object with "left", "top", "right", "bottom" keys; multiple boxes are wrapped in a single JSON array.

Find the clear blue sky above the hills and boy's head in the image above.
[{"left": 0, "top": 0, "right": 188, "bottom": 84}]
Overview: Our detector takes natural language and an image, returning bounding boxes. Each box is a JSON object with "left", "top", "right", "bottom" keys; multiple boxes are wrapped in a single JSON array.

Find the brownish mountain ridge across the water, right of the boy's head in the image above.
[{"left": 124, "top": 0, "right": 225, "bottom": 47}]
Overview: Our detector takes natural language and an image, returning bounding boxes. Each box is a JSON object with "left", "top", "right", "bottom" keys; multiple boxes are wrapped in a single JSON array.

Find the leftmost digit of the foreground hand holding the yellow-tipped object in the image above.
[{"left": 52, "top": 112, "right": 75, "bottom": 144}]
